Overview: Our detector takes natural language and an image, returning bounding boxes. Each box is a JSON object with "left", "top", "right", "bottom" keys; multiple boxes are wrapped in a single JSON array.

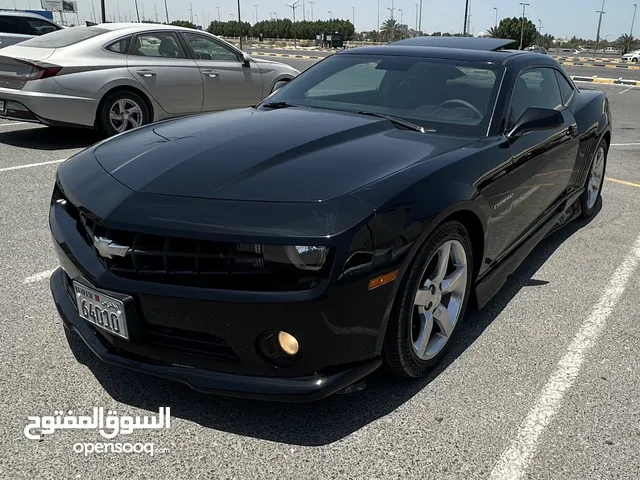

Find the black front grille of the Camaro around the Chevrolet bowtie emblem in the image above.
[{"left": 60, "top": 194, "right": 327, "bottom": 291}]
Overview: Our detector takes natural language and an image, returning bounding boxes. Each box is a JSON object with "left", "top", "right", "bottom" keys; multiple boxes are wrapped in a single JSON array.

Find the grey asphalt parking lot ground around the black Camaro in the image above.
[{"left": 0, "top": 79, "right": 640, "bottom": 480}]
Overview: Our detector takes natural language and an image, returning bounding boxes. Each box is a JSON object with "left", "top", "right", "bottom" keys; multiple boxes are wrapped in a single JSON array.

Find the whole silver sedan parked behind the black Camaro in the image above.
[{"left": 0, "top": 23, "right": 300, "bottom": 135}]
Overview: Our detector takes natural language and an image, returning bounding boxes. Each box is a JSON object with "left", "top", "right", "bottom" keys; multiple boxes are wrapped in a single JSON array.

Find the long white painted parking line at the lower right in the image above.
[{"left": 489, "top": 237, "right": 640, "bottom": 480}]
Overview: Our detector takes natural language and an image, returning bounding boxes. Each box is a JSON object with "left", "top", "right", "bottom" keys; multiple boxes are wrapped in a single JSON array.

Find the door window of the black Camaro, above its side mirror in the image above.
[{"left": 509, "top": 68, "right": 563, "bottom": 126}]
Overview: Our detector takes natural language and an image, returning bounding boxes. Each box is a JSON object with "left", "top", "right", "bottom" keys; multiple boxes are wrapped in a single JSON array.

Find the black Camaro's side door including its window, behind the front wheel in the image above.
[{"left": 507, "top": 67, "right": 579, "bottom": 239}]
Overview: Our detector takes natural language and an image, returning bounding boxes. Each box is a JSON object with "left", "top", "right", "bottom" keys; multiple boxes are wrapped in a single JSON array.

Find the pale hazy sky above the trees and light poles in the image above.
[{"left": 6, "top": 0, "right": 640, "bottom": 40}]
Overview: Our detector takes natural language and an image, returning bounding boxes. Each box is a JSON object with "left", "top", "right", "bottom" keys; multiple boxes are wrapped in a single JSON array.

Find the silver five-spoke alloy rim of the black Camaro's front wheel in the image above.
[{"left": 411, "top": 240, "right": 467, "bottom": 360}]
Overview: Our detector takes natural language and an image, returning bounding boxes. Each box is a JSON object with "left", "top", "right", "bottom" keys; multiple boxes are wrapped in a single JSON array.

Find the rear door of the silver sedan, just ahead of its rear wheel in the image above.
[{"left": 127, "top": 31, "right": 204, "bottom": 115}]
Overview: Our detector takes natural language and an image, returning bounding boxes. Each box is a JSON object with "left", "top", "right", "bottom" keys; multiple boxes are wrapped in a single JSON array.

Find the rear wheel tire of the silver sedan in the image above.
[{"left": 97, "top": 91, "right": 152, "bottom": 137}]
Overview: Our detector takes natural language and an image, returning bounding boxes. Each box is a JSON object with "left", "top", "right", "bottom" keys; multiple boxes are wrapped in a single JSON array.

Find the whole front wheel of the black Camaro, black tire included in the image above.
[{"left": 383, "top": 221, "right": 474, "bottom": 378}]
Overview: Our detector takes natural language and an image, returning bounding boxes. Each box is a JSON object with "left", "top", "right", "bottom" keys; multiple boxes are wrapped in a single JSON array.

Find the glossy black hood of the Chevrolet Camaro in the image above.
[{"left": 93, "top": 107, "right": 475, "bottom": 202}]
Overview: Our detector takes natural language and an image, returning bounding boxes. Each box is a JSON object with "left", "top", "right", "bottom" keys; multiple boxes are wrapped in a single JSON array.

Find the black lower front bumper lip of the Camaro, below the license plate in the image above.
[{"left": 50, "top": 268, "right": 382, "bottom": 402}]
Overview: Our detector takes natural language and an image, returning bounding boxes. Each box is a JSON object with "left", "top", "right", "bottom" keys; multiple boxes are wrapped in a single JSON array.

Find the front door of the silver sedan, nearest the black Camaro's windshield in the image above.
[{"left": 182, "top": 32, "right": 263, "bottom": 111}]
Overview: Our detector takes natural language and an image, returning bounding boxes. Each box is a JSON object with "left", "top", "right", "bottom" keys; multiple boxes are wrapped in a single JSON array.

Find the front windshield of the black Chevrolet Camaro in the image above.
[{"left": 263, "top": 54, "right": 503, "bottom": 136}]
